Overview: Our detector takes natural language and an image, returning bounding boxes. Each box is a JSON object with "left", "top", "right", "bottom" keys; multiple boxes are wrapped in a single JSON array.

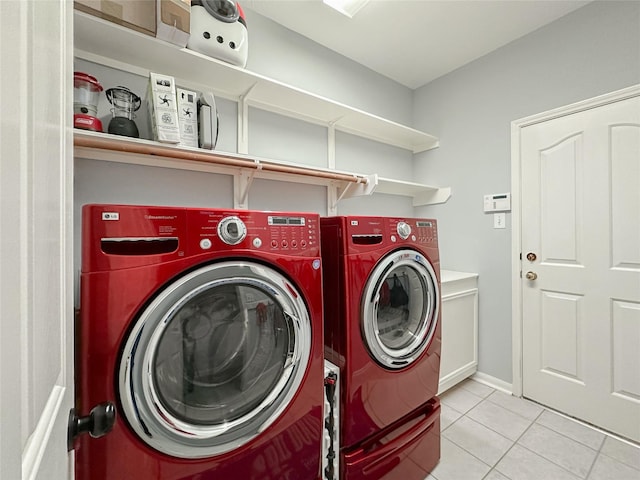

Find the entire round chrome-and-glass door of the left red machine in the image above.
[{"left": 119, "top": 262, "right": 311, "bottom": 458}]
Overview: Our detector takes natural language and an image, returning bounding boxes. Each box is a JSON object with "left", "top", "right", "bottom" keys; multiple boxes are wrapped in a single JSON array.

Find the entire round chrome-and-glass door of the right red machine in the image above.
[{"left": 361, "top": 249, "right": 440, "bottom": 369}]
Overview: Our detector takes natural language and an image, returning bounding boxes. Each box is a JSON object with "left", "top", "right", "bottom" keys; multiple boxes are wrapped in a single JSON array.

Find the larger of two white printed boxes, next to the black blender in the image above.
[{"left": 147, "top": 72, "right": 180, "bottom": 143}]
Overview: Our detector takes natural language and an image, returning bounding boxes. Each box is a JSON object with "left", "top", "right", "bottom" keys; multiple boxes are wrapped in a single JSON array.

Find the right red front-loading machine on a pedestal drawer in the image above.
[{"left": 320, "top": 216, "right": 441, "bottom": 480}]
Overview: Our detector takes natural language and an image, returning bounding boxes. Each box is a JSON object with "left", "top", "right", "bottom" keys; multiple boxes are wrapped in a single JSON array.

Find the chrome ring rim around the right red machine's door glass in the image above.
[{"left": 361, "top": 249, "right": 440, "bottom": 369}]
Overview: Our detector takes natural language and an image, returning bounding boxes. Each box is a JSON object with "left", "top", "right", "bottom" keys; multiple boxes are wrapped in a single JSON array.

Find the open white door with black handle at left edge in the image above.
[{"left": 0, "top": 0, "right": 73, "bottom": 480}]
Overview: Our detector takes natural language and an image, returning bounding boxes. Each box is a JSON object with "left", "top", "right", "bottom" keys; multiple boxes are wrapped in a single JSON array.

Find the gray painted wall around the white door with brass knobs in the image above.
[{"left": 414, "top": 1, "right": 640, "bottom": 382}]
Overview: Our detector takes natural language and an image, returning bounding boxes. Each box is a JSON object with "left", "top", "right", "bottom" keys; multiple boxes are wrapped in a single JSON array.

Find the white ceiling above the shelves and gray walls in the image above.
[{"left": 244, "top": 0, "right": 590, "bottom": 89}]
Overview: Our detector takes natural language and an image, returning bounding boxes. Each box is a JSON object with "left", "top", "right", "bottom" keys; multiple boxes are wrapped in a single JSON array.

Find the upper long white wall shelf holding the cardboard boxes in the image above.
[{"left": 74, "top": 11, "right": 438, "bottom": 153}]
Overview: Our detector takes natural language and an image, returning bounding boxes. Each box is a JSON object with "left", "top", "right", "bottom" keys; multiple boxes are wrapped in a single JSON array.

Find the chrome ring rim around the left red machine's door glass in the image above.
[{"left": 118, "top": 261, "right": 312, "bottom": 458}]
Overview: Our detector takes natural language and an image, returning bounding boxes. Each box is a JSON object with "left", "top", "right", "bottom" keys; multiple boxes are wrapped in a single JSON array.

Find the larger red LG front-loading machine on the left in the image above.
[{"left": 72, "top": 205, "right": 324, "bottom": 480}]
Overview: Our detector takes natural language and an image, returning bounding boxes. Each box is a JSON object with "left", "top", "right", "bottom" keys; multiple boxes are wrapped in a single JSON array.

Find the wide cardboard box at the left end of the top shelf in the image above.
[{"left": 74, "top": 0, "right": 156, "bottom": 37}]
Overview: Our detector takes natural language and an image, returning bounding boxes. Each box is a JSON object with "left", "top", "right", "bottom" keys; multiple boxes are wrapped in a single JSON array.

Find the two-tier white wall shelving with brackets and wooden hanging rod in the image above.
[{"left": 74, "top": 11, "right": 451, "bottom": 213}]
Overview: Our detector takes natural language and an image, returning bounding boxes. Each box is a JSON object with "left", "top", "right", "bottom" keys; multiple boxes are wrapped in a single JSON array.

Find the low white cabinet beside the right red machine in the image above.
[{"left": 438, "top": 270, "right": 478, "bottom": 393}]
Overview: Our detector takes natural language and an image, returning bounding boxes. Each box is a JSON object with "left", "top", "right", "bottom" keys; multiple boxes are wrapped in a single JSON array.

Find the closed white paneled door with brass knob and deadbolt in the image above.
[{"left": 520, "top": 93, "right": 640, "bottom": 441}]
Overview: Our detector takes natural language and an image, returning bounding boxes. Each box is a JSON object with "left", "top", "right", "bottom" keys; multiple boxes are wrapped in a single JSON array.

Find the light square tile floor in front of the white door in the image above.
[{"left": 426, "top": 379, "right": 640, "bottom": 480}]
